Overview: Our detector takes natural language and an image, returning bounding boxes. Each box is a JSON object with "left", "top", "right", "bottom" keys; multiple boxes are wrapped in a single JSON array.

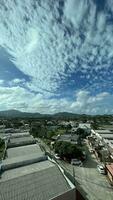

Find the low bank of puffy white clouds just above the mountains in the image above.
[{"left": 0, "top": 86, "right": 113, "bottom": 114}]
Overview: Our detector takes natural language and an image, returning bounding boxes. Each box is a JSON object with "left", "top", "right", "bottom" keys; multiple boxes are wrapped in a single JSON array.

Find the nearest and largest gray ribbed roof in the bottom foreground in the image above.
[{"left": 0, "top": 161, "right": 71, "bottom": 200}]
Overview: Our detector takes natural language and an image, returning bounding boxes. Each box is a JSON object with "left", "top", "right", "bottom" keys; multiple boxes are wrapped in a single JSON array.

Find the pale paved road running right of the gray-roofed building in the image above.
[{"left": 38, "top": 141, "right": 113, "bottom": 200}]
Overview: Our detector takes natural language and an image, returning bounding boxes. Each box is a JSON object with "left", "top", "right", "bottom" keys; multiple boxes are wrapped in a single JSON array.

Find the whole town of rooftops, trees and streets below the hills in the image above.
[{"left": 0, "top": 113, "right": 113, "bottom": 200}]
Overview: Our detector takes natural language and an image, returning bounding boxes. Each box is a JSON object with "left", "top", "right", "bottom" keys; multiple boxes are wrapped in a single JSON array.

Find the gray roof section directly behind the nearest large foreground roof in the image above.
[{"left": 2, "top": 144, "right": 47, "bottom": 169}]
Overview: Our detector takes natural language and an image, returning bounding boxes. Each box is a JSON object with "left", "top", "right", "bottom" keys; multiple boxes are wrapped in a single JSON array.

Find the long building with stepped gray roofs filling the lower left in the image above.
[{"left": 0, "top": 129, "right": 76, "bottom": 200}]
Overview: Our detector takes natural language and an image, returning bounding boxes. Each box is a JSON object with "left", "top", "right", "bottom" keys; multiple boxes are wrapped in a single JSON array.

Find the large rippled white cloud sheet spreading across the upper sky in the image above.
[{"left": 0, "top": 0, "right": 113, "bottom": 94}]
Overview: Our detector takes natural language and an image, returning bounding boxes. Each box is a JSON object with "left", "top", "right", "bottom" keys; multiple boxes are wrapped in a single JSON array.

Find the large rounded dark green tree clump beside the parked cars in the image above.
[{"left": 54, "top": 142, "right": 82, "bottom": 160}]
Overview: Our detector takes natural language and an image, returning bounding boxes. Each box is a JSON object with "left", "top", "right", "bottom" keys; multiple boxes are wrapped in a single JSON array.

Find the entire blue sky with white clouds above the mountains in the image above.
[{"left": 0, "top": 0, "right": 113, "bottom": 115}]
